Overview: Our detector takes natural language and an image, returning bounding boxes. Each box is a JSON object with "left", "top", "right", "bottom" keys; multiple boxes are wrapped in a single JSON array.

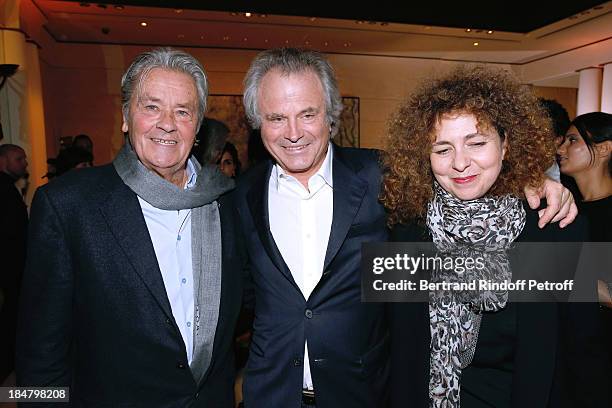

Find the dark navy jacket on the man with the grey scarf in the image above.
[{"left": 17, "top": 165, "right": 244, "bottom": 407}]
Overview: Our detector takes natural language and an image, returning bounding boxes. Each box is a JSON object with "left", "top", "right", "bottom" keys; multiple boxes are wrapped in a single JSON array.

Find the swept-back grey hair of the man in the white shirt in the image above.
[{"left": 243, "top": 48, "right": 343, "bottom": 137}]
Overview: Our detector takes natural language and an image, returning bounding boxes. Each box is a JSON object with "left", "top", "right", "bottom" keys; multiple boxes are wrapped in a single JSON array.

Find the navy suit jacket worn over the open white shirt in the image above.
[{"left": 236, "top": 146, "right": 388, "bottom": 408}]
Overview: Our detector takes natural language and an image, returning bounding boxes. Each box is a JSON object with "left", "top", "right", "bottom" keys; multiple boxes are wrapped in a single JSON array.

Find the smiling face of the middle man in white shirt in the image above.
[{"left": 257, "top": 70, "right": 330, "bottom": 186}]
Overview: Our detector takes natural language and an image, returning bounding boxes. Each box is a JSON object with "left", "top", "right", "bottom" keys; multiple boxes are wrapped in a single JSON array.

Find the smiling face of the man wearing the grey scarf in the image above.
[{"left": 122, "top": 68, "right": 198, "bottom": 187}]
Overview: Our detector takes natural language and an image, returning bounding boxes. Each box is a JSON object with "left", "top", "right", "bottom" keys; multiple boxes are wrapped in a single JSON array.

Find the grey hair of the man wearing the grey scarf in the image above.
[{"left": 121, "top": 48, "right": 208, "bottom": 132}]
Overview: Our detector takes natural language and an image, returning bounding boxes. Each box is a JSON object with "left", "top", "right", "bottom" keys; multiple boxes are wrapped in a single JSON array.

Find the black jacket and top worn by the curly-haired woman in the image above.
[{"left": 391, "top": 205, "right": 596, "bottom": 408}]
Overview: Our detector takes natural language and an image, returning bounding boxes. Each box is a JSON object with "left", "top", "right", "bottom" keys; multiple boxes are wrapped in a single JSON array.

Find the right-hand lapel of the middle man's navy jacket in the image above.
[{"left": 323, "top": 145, "right": 368, "bottom": 271}]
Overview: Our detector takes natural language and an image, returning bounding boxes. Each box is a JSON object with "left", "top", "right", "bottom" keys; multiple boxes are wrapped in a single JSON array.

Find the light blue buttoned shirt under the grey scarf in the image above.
[{"left": 138, "top": 159, "right": 197, "bottom": 364}]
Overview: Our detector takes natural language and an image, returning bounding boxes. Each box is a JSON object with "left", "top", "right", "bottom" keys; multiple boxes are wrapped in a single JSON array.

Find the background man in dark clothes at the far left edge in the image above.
[{"left": 0, "top": 143, "right": 28, "bottom": 383}]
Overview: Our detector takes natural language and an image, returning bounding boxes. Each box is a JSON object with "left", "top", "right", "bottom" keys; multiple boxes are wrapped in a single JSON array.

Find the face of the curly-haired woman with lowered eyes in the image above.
[{"left": 430, "top": 113, "right": 506, "bottom": 200}]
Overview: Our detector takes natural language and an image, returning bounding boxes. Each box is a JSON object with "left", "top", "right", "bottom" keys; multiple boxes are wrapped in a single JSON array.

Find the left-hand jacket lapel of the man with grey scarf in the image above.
[{"left": 100, "top": 177, "right": 176, "bottom": 325}]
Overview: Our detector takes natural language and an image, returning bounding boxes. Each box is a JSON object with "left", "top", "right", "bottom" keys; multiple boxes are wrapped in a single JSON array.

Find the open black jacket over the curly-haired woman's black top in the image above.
[{"left": 390, "top": 205, "right": 604, "bottom": 408}]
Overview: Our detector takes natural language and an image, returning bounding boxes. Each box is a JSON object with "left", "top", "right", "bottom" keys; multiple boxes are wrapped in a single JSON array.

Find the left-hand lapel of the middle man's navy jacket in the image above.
[{"left": 247, "top": 163, "right": 301, "bottom": 293}]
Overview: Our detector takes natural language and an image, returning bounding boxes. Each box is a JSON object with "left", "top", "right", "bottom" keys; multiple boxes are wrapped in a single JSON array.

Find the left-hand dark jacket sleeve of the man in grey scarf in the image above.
[{"left": 16, "top": 189, "right": 74, "bottom": 387}]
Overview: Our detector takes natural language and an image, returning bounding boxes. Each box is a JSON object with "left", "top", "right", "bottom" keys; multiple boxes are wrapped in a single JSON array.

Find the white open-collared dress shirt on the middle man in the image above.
[{"left": 268, "top": 144, "right": 334, "bottom": 389}]
